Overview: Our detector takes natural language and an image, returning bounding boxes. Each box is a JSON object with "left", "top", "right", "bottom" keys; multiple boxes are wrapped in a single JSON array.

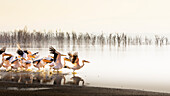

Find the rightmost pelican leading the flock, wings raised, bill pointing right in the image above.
[{"left": 65, "top": 52, "right": 90, "bottom": 74}]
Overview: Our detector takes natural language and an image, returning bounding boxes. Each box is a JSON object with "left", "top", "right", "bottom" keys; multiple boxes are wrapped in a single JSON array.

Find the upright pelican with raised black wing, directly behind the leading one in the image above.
[{"left": 49, "top": 46, "right": 65, "bottom": 72}]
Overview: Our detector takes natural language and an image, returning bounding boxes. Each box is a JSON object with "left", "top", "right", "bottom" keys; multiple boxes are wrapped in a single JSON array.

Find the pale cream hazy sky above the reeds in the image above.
[{"left": 0, "top": 0, "right": 170, "bottom": 32}]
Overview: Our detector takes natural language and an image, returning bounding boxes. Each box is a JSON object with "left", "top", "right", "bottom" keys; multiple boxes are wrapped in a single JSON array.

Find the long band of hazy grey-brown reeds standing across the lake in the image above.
[{"left": 0, "top": 28, "right": 169, "bottom": 48}]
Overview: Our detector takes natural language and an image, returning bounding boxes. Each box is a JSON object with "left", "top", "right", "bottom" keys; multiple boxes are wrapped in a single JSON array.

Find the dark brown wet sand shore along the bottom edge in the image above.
[{"left": 0, "top": 82, "right": 170, "bottom": 96}]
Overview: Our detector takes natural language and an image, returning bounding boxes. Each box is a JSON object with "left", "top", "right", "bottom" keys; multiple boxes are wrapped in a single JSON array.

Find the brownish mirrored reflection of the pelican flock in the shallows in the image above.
[{"left": 0, "top": 72, "right": 84, "bottom": 86}]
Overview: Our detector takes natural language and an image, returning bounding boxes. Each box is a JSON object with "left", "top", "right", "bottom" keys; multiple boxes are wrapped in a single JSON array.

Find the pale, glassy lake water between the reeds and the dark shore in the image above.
[{"left": 1, "top": 45, "right": 170, "bottom": 93}]
